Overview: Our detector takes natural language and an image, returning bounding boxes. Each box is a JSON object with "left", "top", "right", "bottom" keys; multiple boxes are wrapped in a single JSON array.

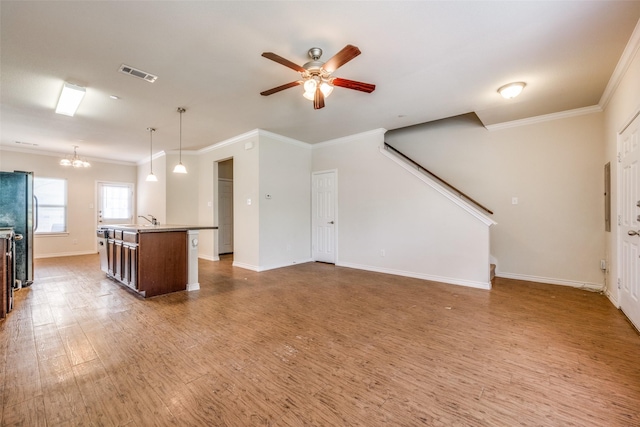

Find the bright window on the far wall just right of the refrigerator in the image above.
[{"left": 33, "top": 176, "right": 67, "bottom": 234}]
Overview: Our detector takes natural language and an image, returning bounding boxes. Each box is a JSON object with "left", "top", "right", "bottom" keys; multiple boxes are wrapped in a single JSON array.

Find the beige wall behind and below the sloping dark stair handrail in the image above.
[{"left": 386, "top": 113, "right": 605, "bottom": 288}]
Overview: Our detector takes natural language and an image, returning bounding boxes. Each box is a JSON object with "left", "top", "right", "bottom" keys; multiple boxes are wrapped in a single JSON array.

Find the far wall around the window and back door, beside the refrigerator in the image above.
[{"left": 0, "top": 149, "right": 137, "bottom": 258}]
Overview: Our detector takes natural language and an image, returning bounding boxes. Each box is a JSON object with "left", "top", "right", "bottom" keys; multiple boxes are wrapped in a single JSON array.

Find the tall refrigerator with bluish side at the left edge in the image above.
[{"left": 0, "top": 171, "right": 37, "bottom": 288}]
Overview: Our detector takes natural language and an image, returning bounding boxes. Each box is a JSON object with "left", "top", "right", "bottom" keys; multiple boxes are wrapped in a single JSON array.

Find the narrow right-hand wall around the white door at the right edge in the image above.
[{"left": 604, "top": 24, "right": 640, "bottom": 306}]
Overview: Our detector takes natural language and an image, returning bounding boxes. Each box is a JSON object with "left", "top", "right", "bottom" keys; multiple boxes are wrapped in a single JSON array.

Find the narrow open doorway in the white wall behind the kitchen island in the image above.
[{"left": 218, "top": 159, "right": 233, "bottom": 255}]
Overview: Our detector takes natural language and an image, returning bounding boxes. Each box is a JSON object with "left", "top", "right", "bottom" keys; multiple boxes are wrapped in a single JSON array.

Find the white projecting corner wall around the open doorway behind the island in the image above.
[{"left": 198, "top": 130, "right": 311, "bottom": 271}]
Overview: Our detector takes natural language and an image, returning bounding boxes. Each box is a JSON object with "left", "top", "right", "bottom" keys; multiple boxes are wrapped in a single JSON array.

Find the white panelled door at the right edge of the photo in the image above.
[{"left": 618, "top": 111, "right": 640, "bottom": 330}]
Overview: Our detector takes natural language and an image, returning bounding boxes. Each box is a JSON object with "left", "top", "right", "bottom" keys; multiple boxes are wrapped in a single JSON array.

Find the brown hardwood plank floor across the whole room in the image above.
[{"left": 0, "top": 256, "right": 640, "bottom": 426}]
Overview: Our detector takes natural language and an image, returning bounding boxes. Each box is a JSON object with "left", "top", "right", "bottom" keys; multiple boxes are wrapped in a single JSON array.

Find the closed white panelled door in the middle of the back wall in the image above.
[{"left": 311, "top": 171, "right": 338, "bottom": 264}]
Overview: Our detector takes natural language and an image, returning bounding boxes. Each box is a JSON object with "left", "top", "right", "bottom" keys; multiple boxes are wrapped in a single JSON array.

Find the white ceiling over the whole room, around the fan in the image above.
[{"left": 0, "top": 0, "right": 640, "bottom": 162}]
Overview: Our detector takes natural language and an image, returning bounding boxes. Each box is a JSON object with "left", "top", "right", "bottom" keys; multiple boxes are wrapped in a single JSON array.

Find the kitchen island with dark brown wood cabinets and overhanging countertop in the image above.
[{"left": 97, "top": 224, "right": 218, "bottom": 297}]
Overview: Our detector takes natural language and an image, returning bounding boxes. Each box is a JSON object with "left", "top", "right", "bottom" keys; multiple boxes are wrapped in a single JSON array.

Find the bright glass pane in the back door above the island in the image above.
[{"left": 98, "top": 182, "right": 133, "bottom": 224}]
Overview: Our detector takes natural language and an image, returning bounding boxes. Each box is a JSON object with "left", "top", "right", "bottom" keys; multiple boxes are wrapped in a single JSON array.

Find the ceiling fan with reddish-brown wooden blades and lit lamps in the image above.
[{"left": 260, "top": 44, "right": 376, "bottom": 110}]
